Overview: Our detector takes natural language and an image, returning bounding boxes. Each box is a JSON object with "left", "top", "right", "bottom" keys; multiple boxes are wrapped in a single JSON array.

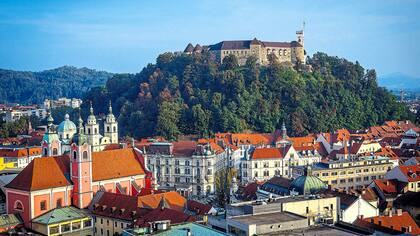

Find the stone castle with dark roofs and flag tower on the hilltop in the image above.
[{"left": 184, "top": 30, "right": 306, "bottom": 65}]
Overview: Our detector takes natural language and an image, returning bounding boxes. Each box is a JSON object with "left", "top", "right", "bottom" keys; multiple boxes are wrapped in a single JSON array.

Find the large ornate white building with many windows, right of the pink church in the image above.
[{"left": 144, "top": 141, "right": 227, "bottom": 196}]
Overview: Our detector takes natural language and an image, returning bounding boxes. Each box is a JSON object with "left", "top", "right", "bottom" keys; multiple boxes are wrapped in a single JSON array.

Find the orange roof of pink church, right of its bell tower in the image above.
[{"left": 92, "top": 148, "right": 145, "bottom": 181}]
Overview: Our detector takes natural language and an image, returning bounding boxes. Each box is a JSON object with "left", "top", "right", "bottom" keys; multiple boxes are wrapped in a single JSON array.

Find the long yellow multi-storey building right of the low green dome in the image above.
[{"left": 293, "top": 156, "right": 393, "bottom": 190}]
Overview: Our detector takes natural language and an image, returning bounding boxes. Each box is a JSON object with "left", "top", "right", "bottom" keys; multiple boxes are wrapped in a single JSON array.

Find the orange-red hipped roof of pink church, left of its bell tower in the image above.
[{"left": 6, "top": 156, "right": 72, "bottom": 191}]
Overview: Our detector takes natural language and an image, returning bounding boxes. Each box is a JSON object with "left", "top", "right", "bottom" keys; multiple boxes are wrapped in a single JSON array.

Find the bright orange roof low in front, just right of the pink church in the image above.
[{"left": 137, "top": 192, "right": 187, "bottom": 211}]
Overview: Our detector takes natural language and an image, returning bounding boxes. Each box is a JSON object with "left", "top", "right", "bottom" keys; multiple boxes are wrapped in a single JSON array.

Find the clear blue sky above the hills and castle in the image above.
[{"left": 0, "top": 0, "right": 420, "bottom": 77}]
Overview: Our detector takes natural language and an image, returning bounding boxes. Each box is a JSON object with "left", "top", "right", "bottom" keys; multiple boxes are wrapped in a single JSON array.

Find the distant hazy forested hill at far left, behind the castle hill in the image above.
[{"left": 0, "top": 66, "right": 112, "bottom": 104}]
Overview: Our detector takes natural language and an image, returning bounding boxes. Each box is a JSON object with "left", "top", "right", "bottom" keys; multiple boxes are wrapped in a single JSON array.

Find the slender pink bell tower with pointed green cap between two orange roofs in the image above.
[{"left": 70, "top": 117, "right": 93, "bottom": 208}]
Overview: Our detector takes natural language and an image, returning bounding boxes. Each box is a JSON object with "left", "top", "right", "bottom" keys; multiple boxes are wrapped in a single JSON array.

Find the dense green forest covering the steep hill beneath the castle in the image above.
[{"left": 84, "top": 53, "right": 414, "bottom": 139}]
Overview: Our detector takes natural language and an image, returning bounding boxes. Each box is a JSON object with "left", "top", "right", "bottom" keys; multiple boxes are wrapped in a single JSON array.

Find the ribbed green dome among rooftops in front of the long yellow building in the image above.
[{"left": 289, "top": 167, "right": 327, "bottom": 195}]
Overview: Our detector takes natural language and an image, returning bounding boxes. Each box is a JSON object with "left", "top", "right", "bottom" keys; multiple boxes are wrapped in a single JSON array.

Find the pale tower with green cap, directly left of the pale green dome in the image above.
[{"left": 41, "top": 112, "right": 62, "bottom": 156}]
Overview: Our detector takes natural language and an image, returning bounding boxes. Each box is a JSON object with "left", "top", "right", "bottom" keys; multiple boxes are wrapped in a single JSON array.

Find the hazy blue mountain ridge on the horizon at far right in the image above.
[{"left": 378, "top": 72, "right": 420, "bottom": 91}]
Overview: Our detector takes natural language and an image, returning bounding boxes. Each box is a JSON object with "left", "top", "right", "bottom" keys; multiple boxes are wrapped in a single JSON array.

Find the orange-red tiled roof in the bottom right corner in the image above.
[{"left": 355, "top": 212, "right": 420, "bottom": 235}]
